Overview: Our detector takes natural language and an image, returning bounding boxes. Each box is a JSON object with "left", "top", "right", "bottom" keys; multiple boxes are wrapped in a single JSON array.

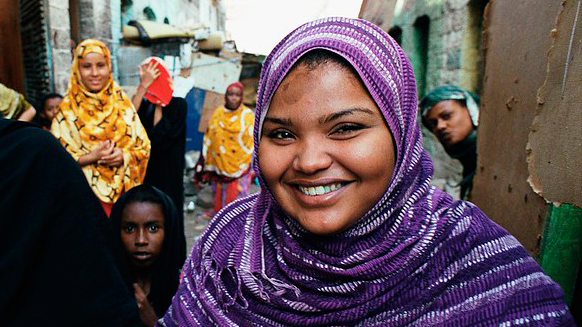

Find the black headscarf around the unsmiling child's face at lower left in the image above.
[{"left": 110, "top": 185, "right": 186, "bottom": 317}]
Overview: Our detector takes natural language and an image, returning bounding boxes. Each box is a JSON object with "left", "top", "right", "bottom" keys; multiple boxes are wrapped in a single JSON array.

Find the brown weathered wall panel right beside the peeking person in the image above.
[{"left": 473, "top": 0, "right": 561, "bottom": 255}]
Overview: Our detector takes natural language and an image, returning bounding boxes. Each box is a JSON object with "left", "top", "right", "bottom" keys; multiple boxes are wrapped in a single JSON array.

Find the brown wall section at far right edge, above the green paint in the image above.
[{"left": 527, "top": 0, "right": 582, "bottom": 207}]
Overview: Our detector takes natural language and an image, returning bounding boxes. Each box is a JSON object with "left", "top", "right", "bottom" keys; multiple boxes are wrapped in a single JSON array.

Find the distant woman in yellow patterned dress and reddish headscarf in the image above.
[{"left": 198, "top": 82, "right": 255, "bottom": 213}]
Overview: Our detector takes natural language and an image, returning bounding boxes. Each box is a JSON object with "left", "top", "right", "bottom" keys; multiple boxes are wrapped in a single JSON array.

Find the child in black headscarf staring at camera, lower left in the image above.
[{"left": 111, "top": 185, "right": 186, "bottom": 326}]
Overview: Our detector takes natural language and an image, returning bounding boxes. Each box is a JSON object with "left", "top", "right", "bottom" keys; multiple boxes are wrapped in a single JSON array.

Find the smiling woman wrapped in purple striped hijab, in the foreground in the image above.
[{"left": 163, "top": 18, "right": 574, "bottom": 326}]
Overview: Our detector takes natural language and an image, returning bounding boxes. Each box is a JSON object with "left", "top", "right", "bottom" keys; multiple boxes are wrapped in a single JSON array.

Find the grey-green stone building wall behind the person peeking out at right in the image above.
[{"left": 360, "top": 0, "right": 488, "bottom": 197}]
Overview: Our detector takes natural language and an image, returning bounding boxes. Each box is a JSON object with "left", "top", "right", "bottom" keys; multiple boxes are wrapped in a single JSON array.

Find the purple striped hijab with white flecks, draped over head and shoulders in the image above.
[{"left": 160, "top": 18, "right": 573, "bottom": 326}]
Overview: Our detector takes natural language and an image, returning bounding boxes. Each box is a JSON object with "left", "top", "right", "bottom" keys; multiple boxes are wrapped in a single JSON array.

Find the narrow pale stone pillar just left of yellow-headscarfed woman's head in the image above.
[{"left": 48, "top": 0, "right": 72, "bottom": 94}]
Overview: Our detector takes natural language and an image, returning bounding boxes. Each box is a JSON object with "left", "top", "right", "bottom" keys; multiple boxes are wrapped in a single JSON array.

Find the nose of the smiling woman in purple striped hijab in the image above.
[{"left": 293, "top": 138, "right": 333, "bottom": 174}]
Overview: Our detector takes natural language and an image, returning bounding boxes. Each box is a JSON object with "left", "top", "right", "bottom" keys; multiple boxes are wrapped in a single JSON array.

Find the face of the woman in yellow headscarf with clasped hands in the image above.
[{"left": 79, "top": 52, "right": 111, "bottom": 93}]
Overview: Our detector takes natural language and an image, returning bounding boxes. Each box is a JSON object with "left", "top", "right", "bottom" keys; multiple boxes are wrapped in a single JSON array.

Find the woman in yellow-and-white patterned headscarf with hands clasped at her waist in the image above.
[{"left": 51, "top": 39, "right": 150, "bottom": 215}]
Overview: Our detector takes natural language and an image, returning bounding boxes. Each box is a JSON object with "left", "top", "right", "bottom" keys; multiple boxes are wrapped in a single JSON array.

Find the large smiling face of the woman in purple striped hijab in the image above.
[{"left": 259, "top": 63, "right": 395, "bottom": 234}]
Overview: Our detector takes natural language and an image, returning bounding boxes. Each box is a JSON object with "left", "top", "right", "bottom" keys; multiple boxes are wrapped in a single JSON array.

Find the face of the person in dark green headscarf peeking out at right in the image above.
[{"left": 426, "top": 100, "right": 473, "bottom": 147}]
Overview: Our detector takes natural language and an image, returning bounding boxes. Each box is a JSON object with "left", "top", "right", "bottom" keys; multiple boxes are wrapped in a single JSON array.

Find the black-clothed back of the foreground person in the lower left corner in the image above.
[{"left": 0, "top": 119, "right": 140, "bottom": 327}]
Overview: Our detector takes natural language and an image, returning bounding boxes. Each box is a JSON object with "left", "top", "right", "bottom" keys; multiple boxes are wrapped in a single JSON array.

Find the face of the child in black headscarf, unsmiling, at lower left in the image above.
[{"left": 121, "top": 202, "right": 164, "bottom": 268}]
